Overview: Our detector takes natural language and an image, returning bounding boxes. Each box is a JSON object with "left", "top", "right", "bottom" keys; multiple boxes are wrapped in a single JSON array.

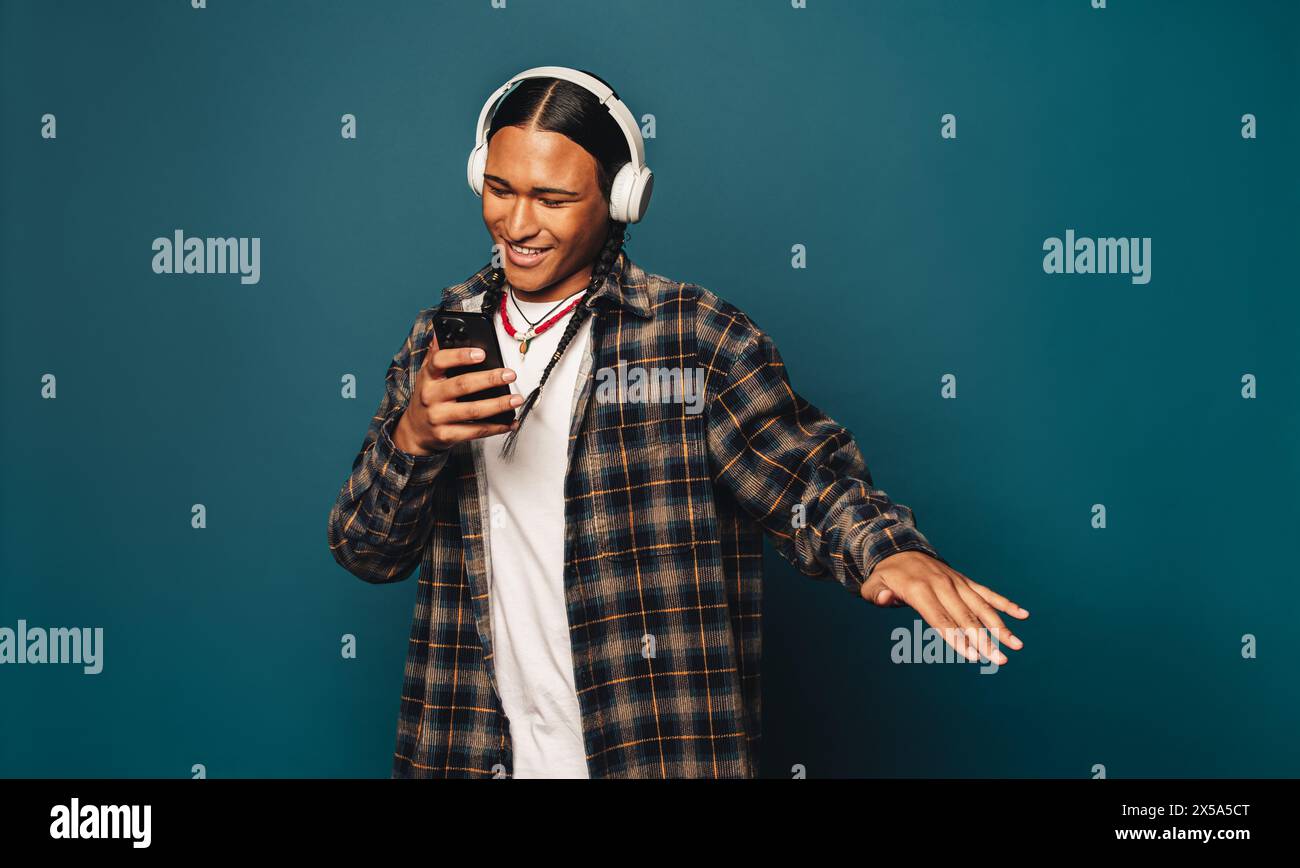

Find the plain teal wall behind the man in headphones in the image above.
[{"left": 0, "top": 0, "right": 1300, "bottom": 777}]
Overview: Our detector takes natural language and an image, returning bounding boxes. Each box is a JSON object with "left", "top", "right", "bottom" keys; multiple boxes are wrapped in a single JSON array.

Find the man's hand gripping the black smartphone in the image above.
[{"left": 393, "top": 335, "right": 524, "bottom": 455}]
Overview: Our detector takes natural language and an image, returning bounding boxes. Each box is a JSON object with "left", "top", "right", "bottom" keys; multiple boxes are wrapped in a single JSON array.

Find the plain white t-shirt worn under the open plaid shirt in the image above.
[{"left": 481, "top": 287, "right": 592, "bottom": 778}]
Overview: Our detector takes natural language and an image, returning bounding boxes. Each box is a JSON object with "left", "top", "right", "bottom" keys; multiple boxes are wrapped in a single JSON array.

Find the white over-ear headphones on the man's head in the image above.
[{"left": 468, "top": 66, "right": 654, "bottom": 223}]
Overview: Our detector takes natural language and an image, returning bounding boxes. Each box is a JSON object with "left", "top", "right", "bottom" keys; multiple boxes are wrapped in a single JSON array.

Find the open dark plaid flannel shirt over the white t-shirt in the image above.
[{"left": 329, "top": 246, "right": 946, "bottom": 778}]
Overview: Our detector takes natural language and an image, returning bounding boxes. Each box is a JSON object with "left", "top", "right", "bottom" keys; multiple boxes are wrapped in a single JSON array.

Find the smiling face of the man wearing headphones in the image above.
[{"left": 484, "top": 126, "right": 610, "bottom": 301}]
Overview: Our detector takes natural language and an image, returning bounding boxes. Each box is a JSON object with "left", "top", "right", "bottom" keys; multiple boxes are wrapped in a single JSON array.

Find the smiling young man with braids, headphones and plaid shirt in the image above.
[{"left": 329, "top": 68, "right": 1028, "bottom": 777}]
